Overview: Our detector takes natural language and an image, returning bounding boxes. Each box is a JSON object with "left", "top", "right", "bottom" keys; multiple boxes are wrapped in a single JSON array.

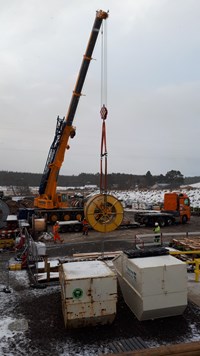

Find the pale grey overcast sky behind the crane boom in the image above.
[{"left": 0, "top": 0, "right": 200, "bottom": 176}]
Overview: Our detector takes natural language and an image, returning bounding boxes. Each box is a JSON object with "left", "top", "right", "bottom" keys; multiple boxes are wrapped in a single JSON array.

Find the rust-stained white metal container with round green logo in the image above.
[{"left": 59, "top": 261, "right": 117, "bottom": 328}]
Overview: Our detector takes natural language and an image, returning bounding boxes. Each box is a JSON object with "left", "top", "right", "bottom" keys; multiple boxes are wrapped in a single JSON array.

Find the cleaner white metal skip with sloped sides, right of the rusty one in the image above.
[{"left": 113, "top": 253, "right": 187, "bottom": 320}]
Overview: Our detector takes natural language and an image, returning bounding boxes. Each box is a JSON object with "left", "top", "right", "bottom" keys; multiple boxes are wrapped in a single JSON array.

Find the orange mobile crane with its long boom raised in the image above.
[{"left": 34, "top": 10, "right": 108, "bottom": 223}]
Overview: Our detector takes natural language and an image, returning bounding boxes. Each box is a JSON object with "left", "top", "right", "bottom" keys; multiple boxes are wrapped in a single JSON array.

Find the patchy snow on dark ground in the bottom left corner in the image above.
[{"left": 0, "top": 270, "right": 106, "bottom": 356}]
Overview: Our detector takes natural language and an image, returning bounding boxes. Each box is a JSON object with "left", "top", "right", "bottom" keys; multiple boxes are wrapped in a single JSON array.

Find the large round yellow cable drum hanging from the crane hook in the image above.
[{"left": 84, "top": 194, "right": 124, "bottom": 232}]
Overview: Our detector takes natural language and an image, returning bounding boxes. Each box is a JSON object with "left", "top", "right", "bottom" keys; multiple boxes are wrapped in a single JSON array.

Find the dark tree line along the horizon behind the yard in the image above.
[{"left": 0, "top": 170, "right": 200, "bottom": 190}]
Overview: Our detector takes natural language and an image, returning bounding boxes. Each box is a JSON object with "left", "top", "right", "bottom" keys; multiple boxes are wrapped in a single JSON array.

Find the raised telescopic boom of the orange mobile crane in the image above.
[{"left": 35, "top": 10, "right": 108, "bottom": 209}]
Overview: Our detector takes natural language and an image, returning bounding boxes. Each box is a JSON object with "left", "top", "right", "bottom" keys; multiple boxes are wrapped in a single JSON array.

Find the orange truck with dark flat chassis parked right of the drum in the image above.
[{"left": 135, "top": 192, "right": 191, "bottom": 227}]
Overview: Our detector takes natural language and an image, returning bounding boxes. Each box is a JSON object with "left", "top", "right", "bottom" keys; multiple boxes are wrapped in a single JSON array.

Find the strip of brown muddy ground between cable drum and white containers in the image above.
[{"left": 48, "top": 212, "right": 200, "bottom": 256}]
